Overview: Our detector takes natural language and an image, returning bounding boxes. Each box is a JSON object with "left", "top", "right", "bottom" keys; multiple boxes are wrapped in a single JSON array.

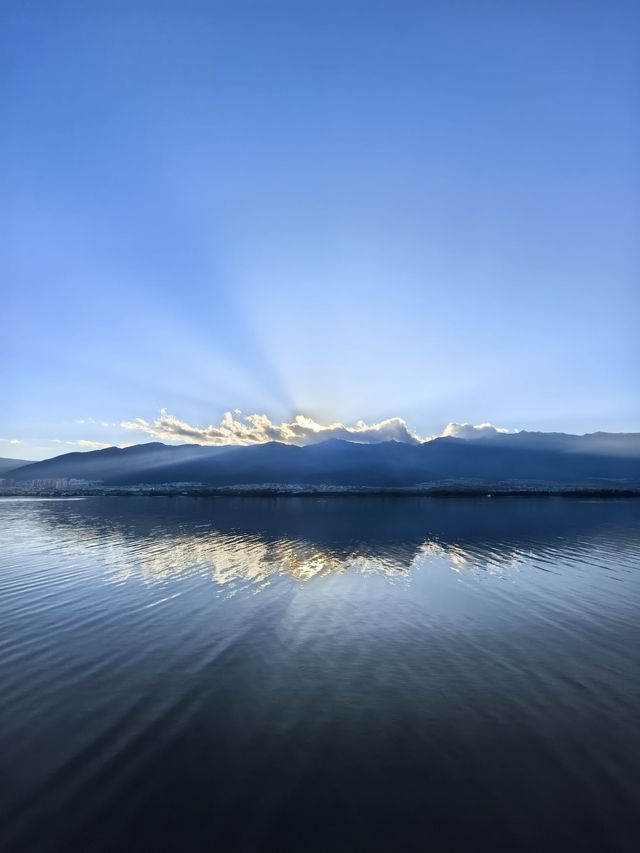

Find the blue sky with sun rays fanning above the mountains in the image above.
[{"left": 0, "top": 0, "right": 640, "bottom": 459}]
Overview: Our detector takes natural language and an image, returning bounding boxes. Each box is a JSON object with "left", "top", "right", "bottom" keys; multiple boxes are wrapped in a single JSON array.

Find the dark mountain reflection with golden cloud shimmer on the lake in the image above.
[{"left": 17, "top": 497, "right": 637, "bottom": 587}]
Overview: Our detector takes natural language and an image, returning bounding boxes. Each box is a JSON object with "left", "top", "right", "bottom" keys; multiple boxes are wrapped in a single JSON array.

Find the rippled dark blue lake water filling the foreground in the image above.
[{"left": 0, "top": 497, "right": 640, "bottom": 853}]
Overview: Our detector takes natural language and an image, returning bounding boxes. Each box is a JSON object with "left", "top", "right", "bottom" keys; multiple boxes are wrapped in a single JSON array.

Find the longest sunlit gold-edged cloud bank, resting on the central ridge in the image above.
[{"left": 120, "top": 409, "right": 422, "bottom": 446}]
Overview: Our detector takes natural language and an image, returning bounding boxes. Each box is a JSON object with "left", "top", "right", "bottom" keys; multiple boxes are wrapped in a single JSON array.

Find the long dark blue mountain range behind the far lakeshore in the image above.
[{"left": 8, "top": 432, "right": 640, "bottom": 488}]
